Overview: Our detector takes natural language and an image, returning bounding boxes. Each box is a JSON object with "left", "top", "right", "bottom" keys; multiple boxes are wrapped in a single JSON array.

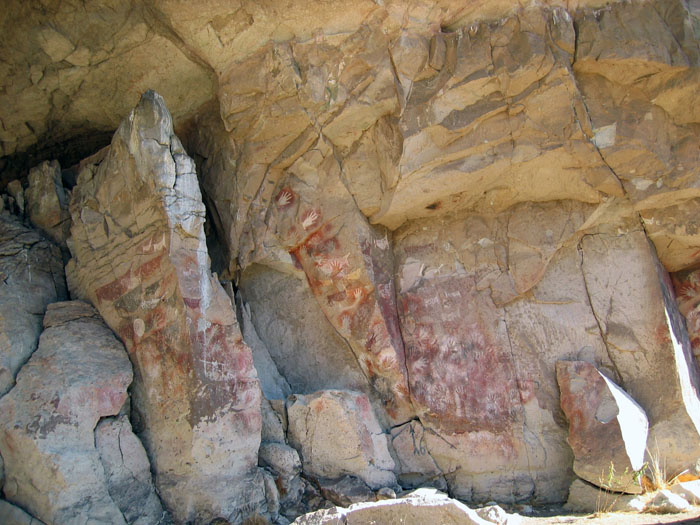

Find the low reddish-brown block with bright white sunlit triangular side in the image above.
[{"left": 556, "top": 361, "right": 649, "bottom": 494}]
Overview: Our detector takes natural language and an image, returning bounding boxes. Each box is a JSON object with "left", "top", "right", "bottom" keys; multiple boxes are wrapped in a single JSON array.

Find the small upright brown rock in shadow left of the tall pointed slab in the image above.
[{"left": 25, "top": 161, "right": 71, "bottom": 246}]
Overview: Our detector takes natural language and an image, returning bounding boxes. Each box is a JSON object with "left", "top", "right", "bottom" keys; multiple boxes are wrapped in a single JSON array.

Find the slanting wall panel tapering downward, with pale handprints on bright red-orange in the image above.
[{"left": 241, "top": 139, "right": 413, "bottom": 422}]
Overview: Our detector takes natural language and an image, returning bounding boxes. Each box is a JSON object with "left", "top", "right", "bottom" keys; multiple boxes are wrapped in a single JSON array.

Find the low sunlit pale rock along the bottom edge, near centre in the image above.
[{"left": 294, "top": 490, "right": 491, "bottom": 525}]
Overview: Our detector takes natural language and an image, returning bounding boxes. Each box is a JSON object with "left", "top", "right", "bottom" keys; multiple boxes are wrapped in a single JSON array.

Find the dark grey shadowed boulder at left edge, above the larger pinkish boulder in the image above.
[{"left": 0, "top": 214, "right": 67, "bottom": 396}]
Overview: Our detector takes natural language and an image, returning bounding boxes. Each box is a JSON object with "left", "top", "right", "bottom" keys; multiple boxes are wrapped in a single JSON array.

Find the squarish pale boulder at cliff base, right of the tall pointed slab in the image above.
[{"left": 288, "top": 390, "right": 396, "bottom": 489}]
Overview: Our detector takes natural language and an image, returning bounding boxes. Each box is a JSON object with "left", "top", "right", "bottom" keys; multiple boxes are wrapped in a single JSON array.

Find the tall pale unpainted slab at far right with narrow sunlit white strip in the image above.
[{"left": 581, "top": 231, "right": 700, "bottom": 475}]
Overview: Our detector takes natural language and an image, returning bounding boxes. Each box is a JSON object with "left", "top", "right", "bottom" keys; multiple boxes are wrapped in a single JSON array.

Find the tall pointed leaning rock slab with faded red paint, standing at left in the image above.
[{"left": 68, "top": 91, "right": 264, "bottom": 522}]
